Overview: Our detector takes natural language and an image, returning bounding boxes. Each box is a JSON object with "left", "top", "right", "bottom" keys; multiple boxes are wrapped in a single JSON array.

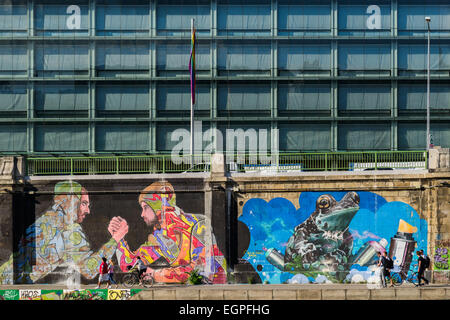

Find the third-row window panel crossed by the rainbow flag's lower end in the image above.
[{"left": 156, "top": 83, "right": 211, "bottom": 112}]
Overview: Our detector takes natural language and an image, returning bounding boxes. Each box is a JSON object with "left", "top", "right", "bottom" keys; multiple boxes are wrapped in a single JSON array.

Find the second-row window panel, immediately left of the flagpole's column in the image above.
[{"left": 96, "top": 41, "right": 150, "bottom": 76}]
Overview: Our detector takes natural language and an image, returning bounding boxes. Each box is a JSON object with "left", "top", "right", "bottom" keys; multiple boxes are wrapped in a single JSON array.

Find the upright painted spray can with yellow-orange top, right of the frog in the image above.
[{"left": 389, "top": 219, "right": 417, "bottom": 274}]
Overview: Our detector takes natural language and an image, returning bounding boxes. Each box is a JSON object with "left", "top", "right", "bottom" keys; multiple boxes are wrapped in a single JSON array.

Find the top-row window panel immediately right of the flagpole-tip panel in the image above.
[{"left": 217, "top": 4, "right": 271, "bottom": 35}]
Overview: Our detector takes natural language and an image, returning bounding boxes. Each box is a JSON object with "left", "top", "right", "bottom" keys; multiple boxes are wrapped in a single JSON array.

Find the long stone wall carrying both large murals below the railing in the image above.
[{"left": 0, "top": 158, "right": 450, "bottom": 284}]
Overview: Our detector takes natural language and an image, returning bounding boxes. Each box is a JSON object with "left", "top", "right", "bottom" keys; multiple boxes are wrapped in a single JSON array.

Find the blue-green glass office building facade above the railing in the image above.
[{"left": 0, "top": 0, "right": 450, "bottom": 155}]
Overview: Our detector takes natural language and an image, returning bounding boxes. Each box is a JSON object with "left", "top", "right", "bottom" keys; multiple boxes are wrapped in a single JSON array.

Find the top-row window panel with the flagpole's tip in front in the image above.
[{"left": 156, "top": 4, "right": 211, "bottom": 35}]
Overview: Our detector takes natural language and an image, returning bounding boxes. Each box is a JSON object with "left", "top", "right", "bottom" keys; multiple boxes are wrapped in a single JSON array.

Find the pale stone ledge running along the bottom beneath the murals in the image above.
[{"left": 0, "top": 284, "right": 450, "bottom": 300}]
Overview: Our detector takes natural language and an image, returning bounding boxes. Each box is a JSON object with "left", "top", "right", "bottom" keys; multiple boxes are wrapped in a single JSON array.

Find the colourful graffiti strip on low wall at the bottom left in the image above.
[{"left": 0, "top": 289, "right": 141, "bottom": 300}]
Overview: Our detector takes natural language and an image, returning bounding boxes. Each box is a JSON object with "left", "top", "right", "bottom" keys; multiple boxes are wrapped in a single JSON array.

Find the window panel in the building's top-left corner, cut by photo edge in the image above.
[{"left": 0, "top": 4, "right": 28, "bottom": 36}]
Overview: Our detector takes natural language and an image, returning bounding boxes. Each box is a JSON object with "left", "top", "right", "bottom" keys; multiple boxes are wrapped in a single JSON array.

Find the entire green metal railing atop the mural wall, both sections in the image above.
[{"left": 26, "top": 151, "right": 428, "bottom": 176}]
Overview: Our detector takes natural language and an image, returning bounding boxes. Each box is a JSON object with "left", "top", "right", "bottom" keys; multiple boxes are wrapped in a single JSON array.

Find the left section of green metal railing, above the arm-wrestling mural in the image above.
[{"left": 26, "top": 155, "right": 211, "bottom": 176}]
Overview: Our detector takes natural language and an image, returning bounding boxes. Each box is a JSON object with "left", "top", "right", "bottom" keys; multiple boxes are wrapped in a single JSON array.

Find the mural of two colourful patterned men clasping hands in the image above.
[{"left": 0, "top": 181, "right": 226, "bottom": 284}]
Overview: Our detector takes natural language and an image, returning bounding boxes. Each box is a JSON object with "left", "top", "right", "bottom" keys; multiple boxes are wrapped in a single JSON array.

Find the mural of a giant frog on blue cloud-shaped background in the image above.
[{"left": 239, "top": 192, "right": 428, "bottom": 283}]
